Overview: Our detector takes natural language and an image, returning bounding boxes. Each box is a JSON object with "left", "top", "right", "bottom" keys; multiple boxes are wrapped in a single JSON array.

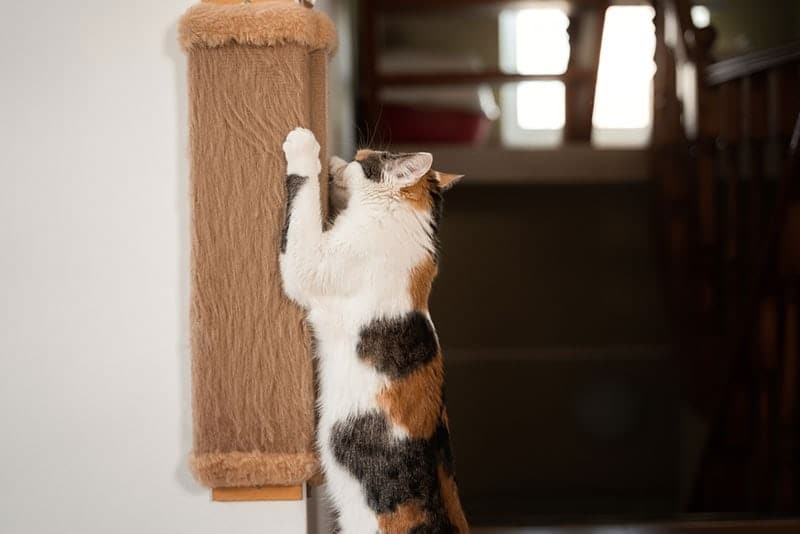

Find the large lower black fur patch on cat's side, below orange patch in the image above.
[{"left": 331, "top": 413, "right": 455, "bottom": 534}]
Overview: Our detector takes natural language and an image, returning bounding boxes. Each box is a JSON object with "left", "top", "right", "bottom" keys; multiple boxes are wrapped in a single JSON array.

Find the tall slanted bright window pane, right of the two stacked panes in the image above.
[{"left": 592, "top": 6, "right": 656, "bottom": 135}]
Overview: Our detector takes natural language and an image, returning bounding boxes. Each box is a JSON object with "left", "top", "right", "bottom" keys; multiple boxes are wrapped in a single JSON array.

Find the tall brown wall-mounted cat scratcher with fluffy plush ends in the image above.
[{"left": 179, "top": 0, "right": 336, "bottom": 500}]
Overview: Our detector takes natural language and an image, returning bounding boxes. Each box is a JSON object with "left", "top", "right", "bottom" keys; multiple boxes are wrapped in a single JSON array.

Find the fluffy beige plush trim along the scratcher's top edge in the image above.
[{"left": 178, "top": 0, "right": 337, "bottom": 55}]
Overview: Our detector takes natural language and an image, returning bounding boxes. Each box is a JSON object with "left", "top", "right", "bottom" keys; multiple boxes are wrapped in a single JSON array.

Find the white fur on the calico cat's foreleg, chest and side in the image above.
[{"left": 280, "top": 129, "right": 431, "bottom": 534}]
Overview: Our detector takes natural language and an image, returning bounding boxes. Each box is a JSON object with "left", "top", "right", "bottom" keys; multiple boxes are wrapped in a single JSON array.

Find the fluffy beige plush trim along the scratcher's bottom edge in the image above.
[{"left": 190, "top": 451, "right": 319, "bottom": 488}]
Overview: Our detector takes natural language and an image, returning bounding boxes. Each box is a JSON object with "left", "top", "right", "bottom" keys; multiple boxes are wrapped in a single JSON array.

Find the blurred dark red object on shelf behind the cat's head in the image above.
[{"left": 380, "top": 104, "right": 492, "bottom": 145}]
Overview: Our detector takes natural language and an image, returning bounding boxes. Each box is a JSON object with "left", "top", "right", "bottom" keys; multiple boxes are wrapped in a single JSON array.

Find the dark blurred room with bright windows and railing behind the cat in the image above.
[{"left": 326, "top": 0, "right": 800, "bottom": 526}]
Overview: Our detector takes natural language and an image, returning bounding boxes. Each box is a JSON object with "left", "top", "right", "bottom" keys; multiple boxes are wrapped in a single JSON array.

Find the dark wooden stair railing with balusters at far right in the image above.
[{"left": 652, "top": 0, "right": 800, "bottom": 514}]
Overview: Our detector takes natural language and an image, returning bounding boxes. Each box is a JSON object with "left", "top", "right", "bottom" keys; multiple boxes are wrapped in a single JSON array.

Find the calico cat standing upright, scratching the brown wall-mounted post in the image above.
[{"left": 280, "top": 128, "right": 469, "bottom": 534}]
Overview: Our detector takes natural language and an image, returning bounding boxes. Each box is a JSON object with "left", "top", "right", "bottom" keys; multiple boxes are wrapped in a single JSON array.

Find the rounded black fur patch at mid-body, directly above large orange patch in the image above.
[{"left": 358, "top": 312, "right": 439, "bottom": 379}]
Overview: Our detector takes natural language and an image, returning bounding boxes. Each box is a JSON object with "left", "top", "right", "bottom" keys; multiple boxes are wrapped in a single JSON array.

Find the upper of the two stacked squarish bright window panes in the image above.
[{"left": 515, "top": 8, "right": 569, "bottom": 74}]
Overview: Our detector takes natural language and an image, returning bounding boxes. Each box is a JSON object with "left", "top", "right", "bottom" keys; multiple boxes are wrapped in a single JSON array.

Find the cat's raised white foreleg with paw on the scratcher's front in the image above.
[{"left": 280, "top": 128, "right": 324, "bottom": 305}]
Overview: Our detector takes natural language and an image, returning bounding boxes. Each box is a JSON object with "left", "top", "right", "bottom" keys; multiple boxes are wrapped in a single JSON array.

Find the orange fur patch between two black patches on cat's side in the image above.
[{"left": 378, "top": 354, "right": 444, "bottom": 439}]
